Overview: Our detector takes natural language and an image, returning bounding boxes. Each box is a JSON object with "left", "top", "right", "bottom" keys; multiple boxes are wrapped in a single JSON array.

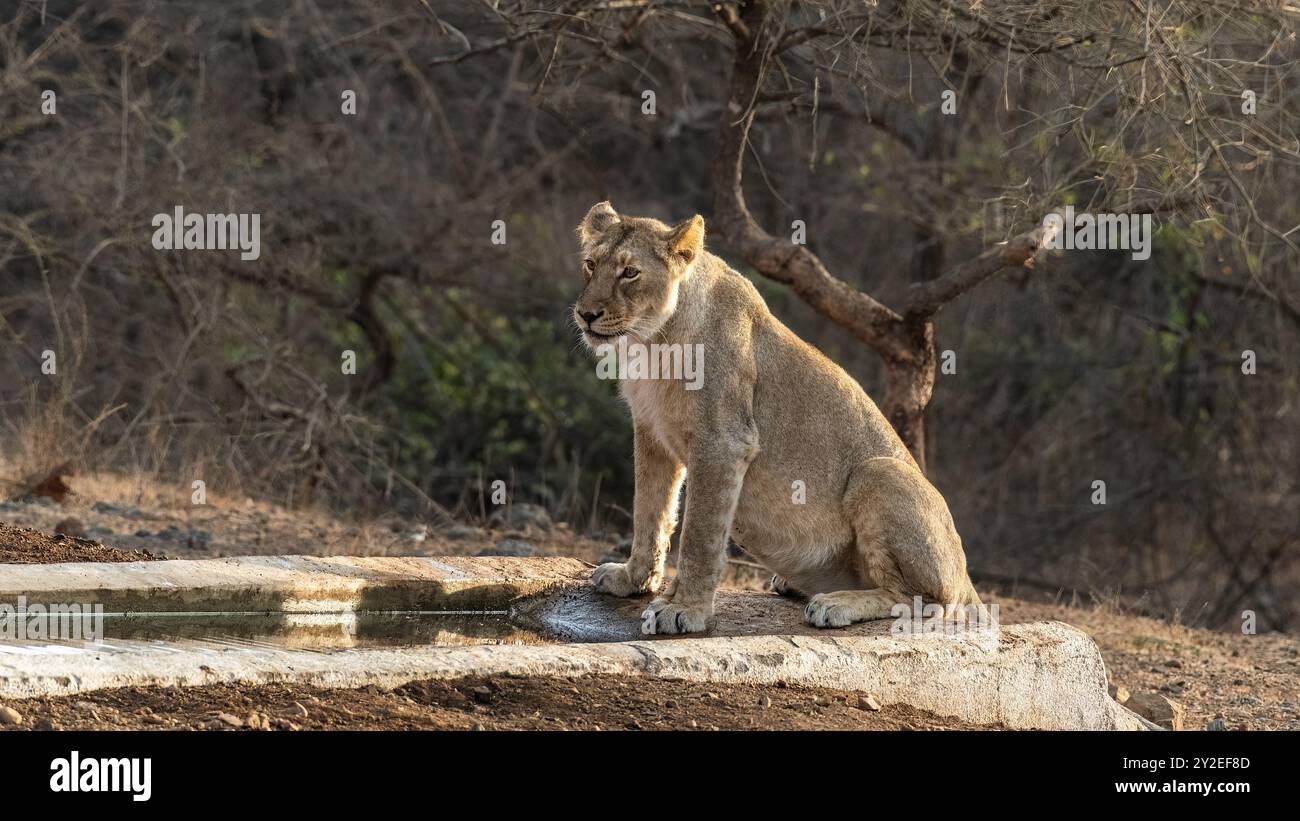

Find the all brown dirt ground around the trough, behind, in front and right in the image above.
[{"left": 0, "top": 467, "right": 1300, "bottom": 730}]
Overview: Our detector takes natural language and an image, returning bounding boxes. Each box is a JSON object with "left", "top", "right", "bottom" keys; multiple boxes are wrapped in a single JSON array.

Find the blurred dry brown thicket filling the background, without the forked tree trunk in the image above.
[{"left": 0, "top": 0, "right": 1300, "bottom": 629}]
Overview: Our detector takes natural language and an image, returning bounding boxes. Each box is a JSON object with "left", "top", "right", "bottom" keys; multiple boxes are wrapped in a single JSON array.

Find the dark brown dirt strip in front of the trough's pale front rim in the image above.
[{"left": 0, "top": 677, "right": 1000, "bottom": 730}]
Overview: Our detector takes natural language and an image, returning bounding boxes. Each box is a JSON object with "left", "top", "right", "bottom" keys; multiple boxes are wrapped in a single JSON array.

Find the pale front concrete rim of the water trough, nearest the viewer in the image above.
[{"left": 0, "top": 622, "right": 1148, "bottom": 730}]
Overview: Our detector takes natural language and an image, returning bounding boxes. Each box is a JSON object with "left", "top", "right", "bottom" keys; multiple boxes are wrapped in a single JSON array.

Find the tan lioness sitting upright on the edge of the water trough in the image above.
[{"left": 573, "top": 203, "right": 979, "bottom": 633}]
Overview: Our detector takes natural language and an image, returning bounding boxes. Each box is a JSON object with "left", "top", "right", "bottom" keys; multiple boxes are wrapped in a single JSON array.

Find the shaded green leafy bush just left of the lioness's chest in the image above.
[{"left": 374, "top": 290, "right": 632, "bottom": 514}]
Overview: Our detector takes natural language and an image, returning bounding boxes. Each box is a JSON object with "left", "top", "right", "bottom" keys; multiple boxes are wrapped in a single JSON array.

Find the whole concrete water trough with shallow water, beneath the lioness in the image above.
[{"left": 0, "top": 556, "right": 1153, "bottom": 730}]
